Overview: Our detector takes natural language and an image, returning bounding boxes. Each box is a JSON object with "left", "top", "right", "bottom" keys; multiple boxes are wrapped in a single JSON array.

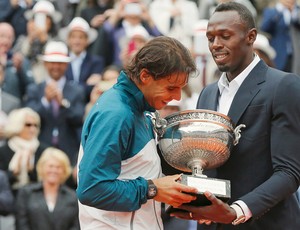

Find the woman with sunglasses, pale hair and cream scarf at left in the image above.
[{"left": 0, "top": 107, "right": 47, "bottom": 194}]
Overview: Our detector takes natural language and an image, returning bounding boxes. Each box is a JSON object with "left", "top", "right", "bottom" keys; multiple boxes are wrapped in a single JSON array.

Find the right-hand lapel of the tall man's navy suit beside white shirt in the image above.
[{"left": 228, "top": 61, "right": 268, "bottom": 124}]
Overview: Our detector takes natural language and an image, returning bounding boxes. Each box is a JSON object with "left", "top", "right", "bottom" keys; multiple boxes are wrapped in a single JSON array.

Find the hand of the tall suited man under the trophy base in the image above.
[{"left": 170, "top": 191, "right": 236, "bottom": 224}]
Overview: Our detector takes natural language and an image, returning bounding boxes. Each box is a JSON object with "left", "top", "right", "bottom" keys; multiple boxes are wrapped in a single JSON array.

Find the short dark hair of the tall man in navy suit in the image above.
[{"left": 214, "top": 2, "right": 256, "bottom": 30}]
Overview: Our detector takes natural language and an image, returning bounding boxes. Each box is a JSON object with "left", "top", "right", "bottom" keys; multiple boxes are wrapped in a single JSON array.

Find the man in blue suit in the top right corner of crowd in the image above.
[{"left": 260, "top": 0, "right": 300, "bottom": 74}]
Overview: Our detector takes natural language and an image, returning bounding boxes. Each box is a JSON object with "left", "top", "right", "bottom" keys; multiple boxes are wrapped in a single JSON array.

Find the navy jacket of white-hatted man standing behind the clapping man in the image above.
[{"left": 65, "top": 53, "right": 104, "bottom": 101}]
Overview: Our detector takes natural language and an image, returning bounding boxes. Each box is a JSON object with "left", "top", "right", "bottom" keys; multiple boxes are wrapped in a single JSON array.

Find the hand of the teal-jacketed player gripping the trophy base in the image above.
[{"left": 153, "top": 174, "right": 198, "bottom": 207}]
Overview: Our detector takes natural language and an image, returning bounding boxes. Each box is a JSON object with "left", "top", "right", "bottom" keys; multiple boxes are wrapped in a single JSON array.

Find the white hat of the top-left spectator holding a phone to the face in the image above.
[{"left": 24, "top": 0, "right": 62, "bottom": 23}]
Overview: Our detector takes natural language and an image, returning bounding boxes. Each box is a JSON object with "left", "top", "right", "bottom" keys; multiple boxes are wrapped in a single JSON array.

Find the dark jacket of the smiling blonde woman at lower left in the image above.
[{"left": 16, "top": 183, "right": 80, "bottom": 230}]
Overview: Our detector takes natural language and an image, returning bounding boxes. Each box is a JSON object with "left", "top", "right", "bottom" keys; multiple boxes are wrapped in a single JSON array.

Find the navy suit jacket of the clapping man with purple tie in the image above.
[{"left": 26, "top": 81, "right": 85, "bottom": 165}]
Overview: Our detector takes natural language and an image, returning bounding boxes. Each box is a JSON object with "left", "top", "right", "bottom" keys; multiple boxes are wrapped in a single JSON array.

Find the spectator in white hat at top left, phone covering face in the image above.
[{"left": 14, "top": 0, "right": 62, "bottom": 82}]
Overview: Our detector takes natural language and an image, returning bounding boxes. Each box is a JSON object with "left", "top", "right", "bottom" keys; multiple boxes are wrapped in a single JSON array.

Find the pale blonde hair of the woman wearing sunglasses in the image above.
[{"left": 4, "top": 107, "right": 41, "bottom": 138}]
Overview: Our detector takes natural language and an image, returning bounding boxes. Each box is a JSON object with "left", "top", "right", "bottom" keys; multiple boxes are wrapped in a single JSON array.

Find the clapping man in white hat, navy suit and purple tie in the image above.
[{"left": 26, "top": 41, "right": 85, "bottom": 166}]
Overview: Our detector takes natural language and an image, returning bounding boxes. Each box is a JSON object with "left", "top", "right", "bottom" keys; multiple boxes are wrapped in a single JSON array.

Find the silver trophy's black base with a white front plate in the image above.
[{"left": 166, "top": 174, "right": 231, "bottom": 214}]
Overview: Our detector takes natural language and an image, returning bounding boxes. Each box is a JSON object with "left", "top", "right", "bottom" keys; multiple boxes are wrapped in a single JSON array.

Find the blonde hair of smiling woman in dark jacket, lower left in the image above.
[{"left": 36, "top": 147, "right": 72, "bottom": 184}]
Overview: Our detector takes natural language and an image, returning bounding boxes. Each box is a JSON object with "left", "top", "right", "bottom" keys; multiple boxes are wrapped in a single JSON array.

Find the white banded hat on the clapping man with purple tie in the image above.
[{"left": 42, "top": 41, "right": 71, "bottom": 63}]
